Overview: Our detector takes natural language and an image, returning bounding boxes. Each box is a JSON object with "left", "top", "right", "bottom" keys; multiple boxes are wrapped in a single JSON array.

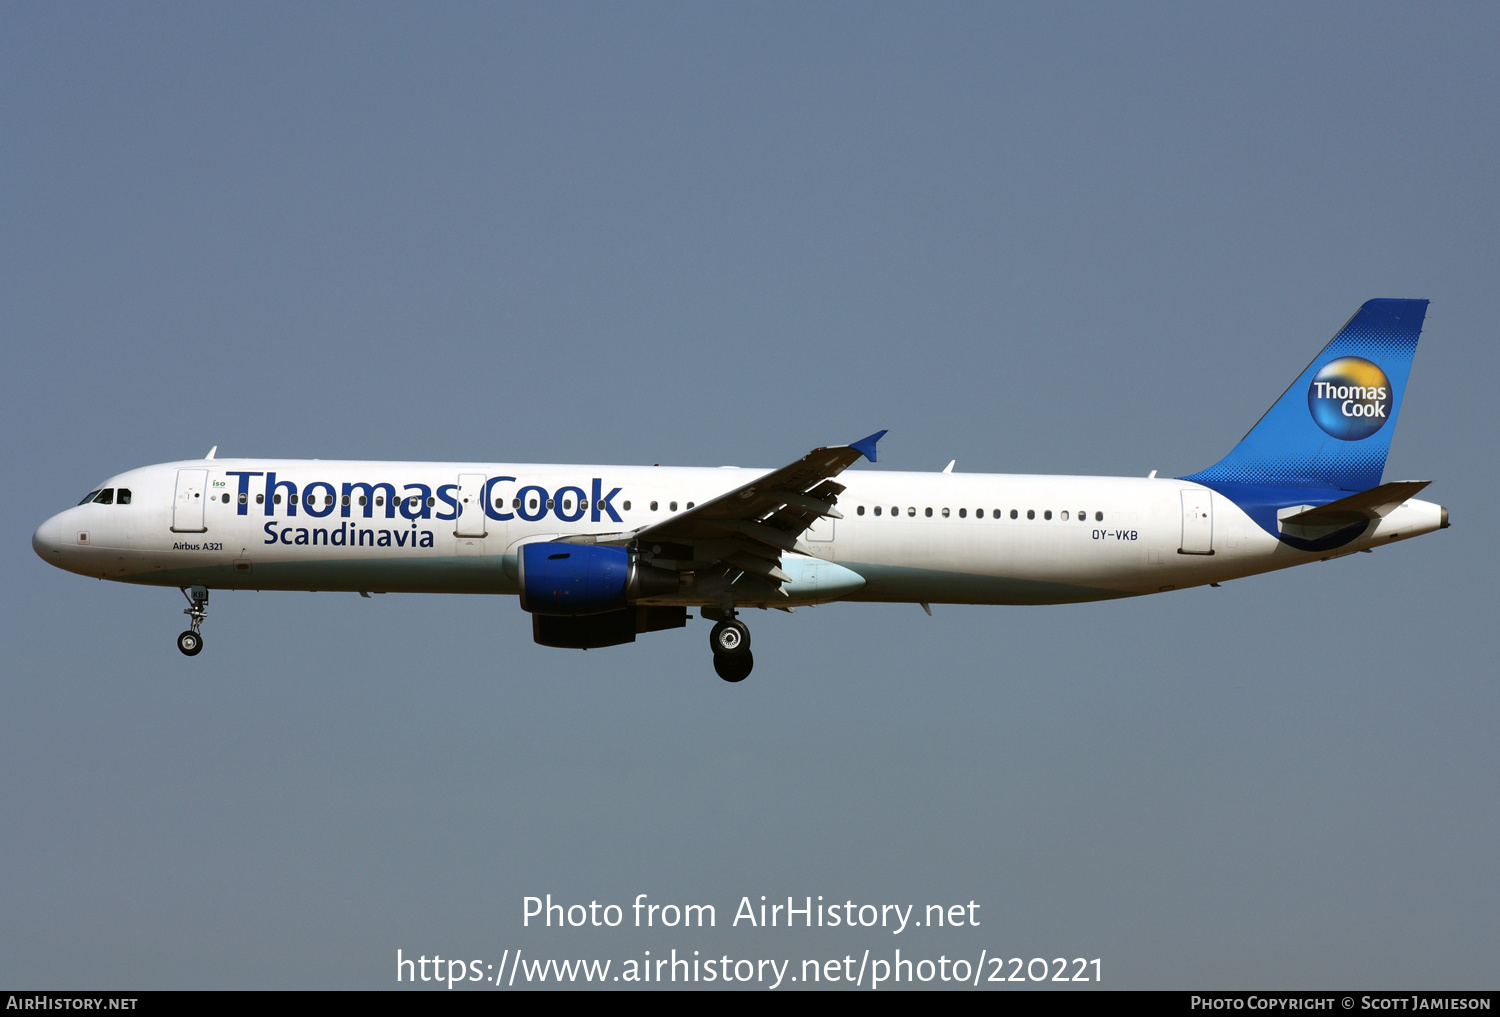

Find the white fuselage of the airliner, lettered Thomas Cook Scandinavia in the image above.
[{"left": 33, "top": 459, "right": 1443, "bottom": 606}]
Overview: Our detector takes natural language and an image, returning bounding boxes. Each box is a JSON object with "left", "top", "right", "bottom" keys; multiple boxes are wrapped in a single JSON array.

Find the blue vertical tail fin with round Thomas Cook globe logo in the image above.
[{"left": 1182, "top": 300, "right": 1427, "bottom": 491}]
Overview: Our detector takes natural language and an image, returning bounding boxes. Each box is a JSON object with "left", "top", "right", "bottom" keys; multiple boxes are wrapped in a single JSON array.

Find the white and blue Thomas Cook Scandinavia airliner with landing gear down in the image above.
[{"left": 32, "top": 300, "right": 1449, "bottom": 683}]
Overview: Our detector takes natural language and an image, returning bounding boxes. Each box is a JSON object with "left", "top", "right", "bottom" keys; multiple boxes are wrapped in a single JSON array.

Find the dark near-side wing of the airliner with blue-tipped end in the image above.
[{"left": 632, "top": 431, "right": 885, "bottom": 591}]
